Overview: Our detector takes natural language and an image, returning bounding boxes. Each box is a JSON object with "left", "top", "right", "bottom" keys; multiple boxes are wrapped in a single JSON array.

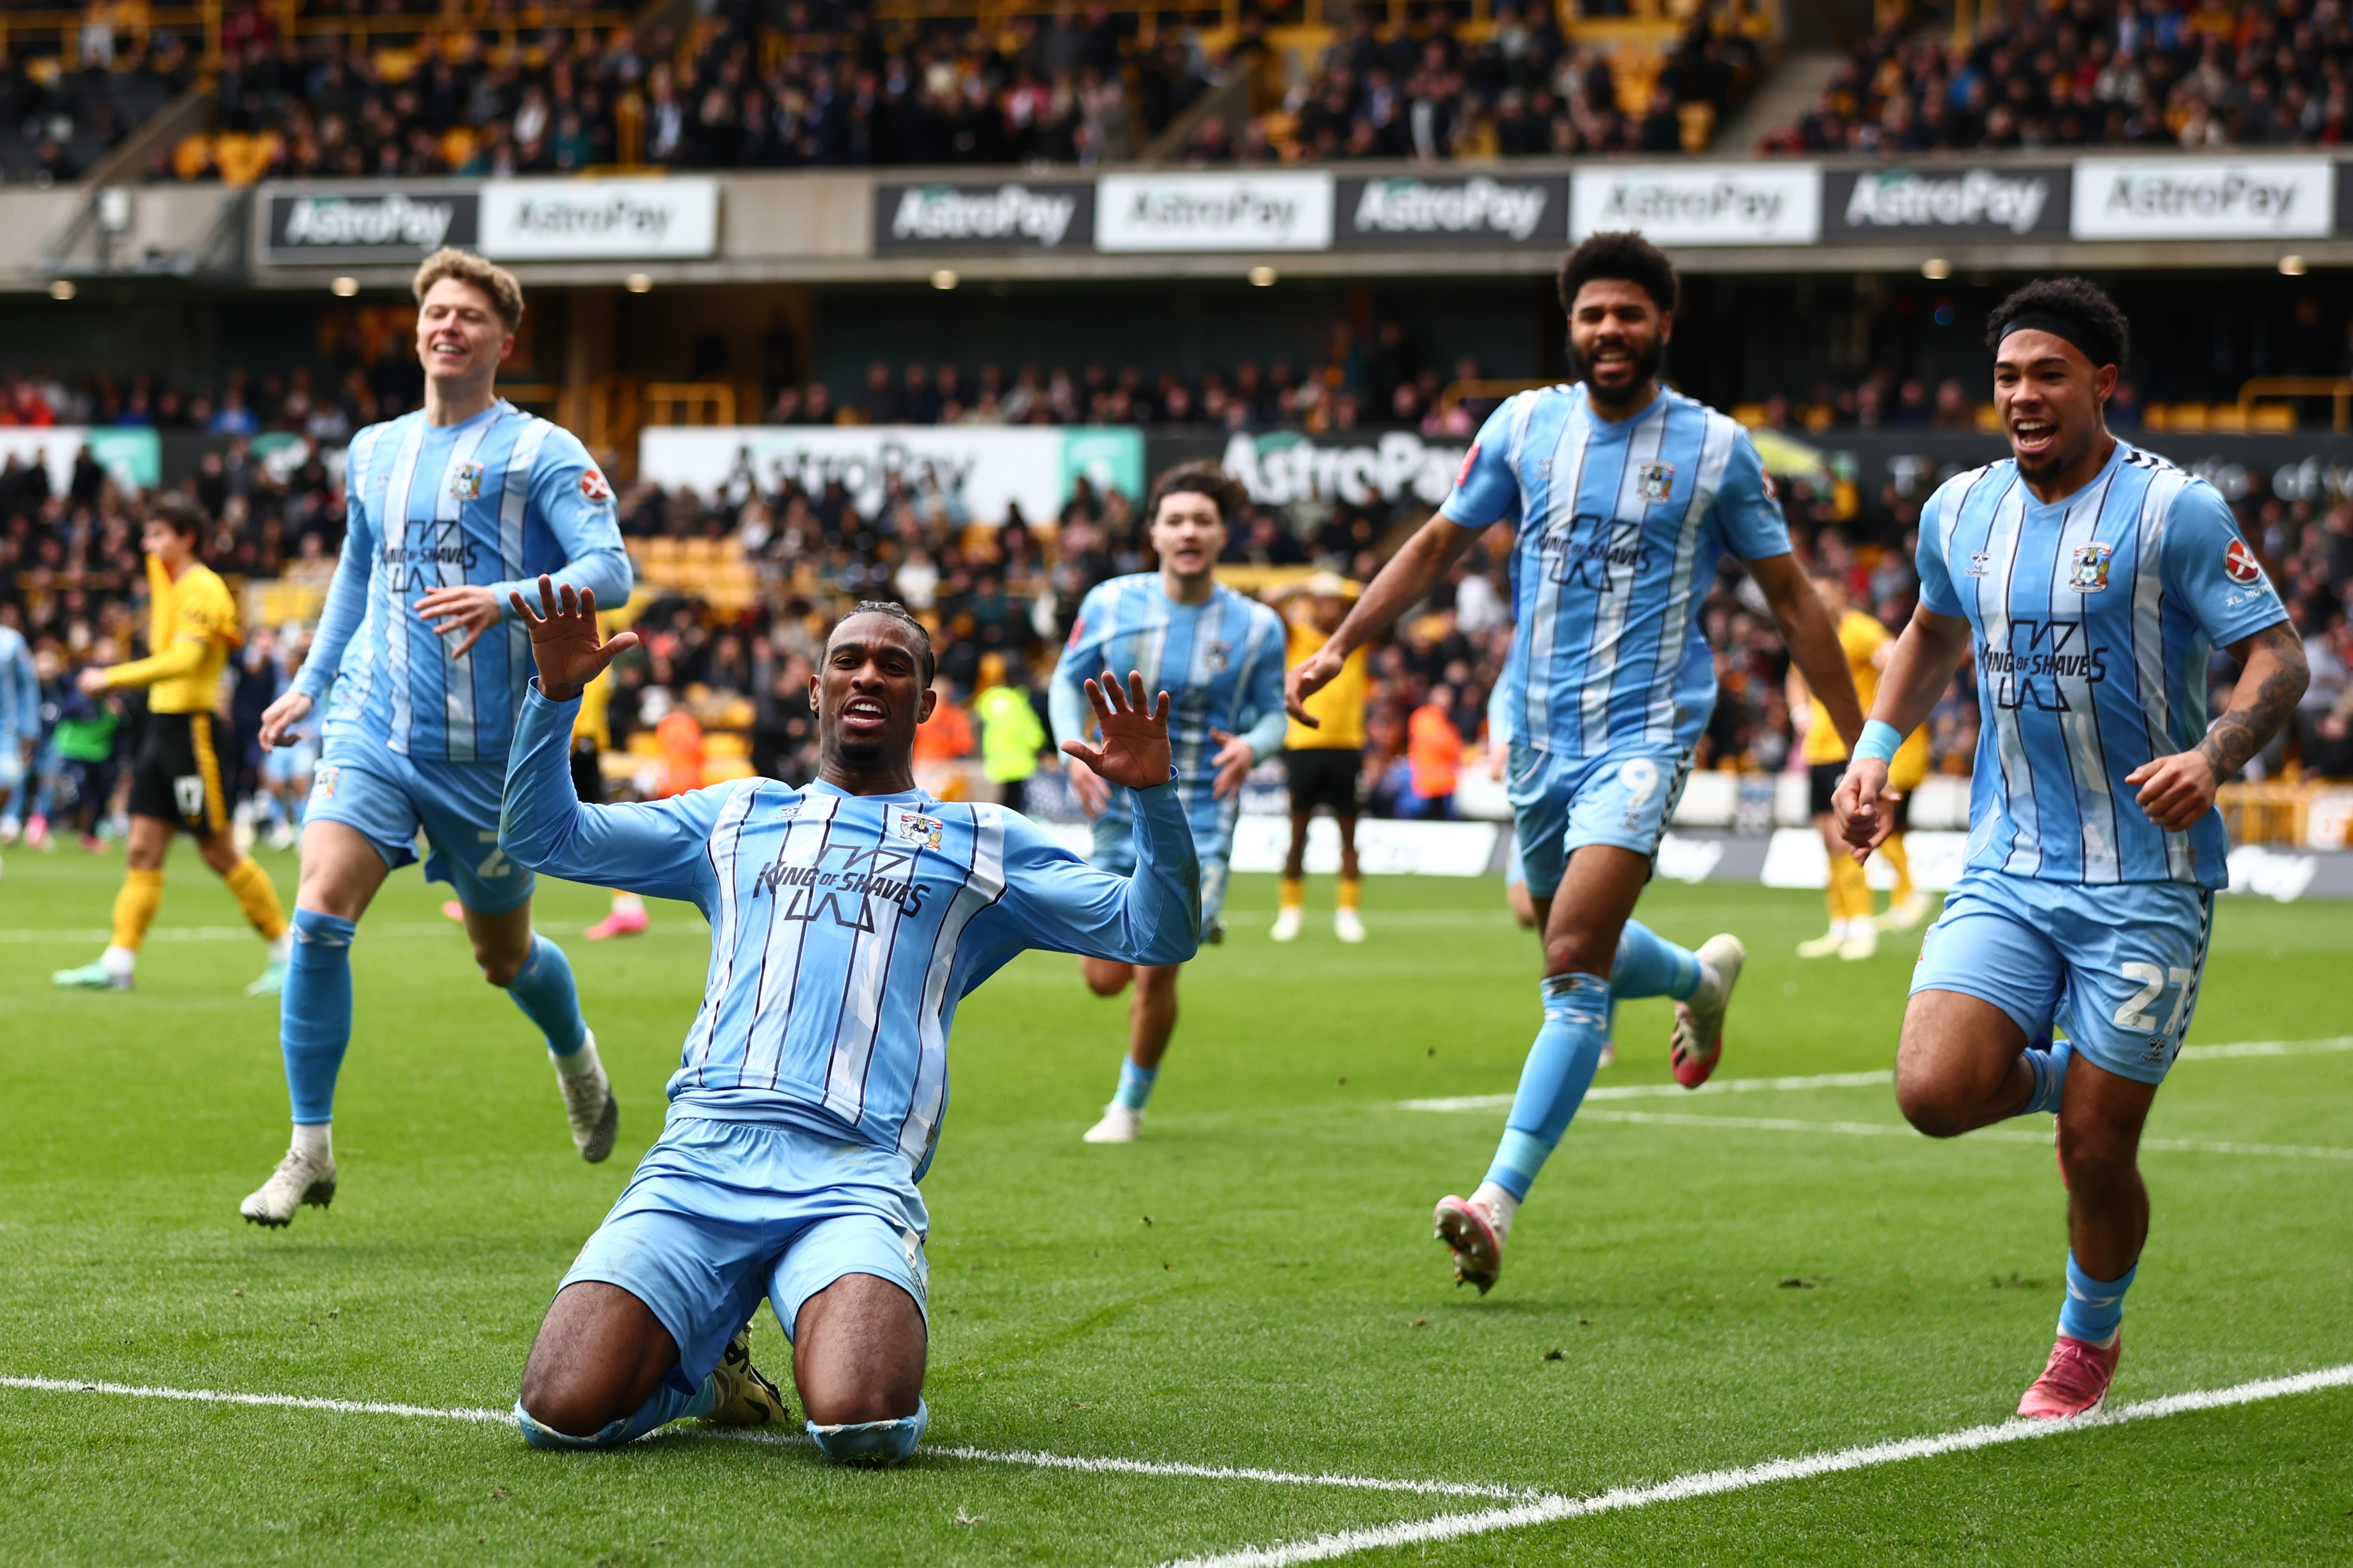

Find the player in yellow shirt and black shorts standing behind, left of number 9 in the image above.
[{"left": 1268, "top": 572, "right": 1372, "bottom": 942}]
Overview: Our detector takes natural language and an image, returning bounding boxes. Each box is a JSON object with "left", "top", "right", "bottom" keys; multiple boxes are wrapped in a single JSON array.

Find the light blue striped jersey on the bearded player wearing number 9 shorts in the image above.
[{"left": 1440, "top": 384, "right": 1788, "bottom": 756}]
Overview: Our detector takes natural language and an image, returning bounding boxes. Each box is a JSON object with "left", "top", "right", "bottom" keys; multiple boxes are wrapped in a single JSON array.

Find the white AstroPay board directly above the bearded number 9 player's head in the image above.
[{"left": 1569, "top": 163, "right": 1821, "bottom": 245}]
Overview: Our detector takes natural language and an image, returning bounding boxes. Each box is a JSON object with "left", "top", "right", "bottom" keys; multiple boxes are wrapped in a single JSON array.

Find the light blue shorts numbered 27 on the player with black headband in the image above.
[{"left": 1913, "top": 866, "right": 2214, "bottom": 1083}]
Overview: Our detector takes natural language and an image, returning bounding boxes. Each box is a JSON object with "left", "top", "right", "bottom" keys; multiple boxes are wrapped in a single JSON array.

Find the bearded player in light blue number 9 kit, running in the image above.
[{"left": 1287, "top": 233, "right": 1864, "bottom": 1295}]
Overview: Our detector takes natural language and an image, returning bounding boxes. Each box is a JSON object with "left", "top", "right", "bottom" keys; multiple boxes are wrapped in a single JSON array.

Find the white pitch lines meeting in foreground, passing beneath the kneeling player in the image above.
[{"left": 0, "top": 1363, "right": 2353, "bottom": 1568}]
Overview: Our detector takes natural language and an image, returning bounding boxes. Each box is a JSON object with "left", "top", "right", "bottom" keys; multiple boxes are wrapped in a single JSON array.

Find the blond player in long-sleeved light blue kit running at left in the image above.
[{"left": 240, "top": 249, "right": 631, "bottom": 1224}]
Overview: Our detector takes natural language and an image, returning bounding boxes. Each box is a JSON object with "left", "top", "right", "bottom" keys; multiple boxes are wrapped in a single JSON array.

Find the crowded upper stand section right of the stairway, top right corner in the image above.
[{"left": 1760, "top": 0, "right": 2353, "bottom": 153}]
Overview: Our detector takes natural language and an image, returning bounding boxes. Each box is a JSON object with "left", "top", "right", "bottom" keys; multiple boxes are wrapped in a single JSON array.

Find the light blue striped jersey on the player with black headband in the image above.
[{"left": 1920, "top": 443, "right": 2287, "bottom": 887}]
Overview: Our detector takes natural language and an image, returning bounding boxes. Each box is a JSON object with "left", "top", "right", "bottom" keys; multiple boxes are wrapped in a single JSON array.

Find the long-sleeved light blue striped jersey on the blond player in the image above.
[{"left": 294, "top": 398, "right": 631, "bottom": 763}]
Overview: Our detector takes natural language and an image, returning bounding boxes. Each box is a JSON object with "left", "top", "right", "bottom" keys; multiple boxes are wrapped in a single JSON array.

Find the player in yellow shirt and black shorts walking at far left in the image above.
[{"left": 49, "top": 495, "right": 290, "bottom": 996}]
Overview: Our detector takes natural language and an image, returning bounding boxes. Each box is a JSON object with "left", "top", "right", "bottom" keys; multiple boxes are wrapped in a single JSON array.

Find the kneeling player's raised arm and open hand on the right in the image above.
[{"left": 986, "top": 671, "right": 1200, "bottom": 968}]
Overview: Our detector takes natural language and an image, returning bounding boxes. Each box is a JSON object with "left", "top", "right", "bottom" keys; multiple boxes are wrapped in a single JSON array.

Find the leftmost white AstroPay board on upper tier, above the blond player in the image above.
[{"left": 482, "top": 179, "right": 720, "bottom": 261}]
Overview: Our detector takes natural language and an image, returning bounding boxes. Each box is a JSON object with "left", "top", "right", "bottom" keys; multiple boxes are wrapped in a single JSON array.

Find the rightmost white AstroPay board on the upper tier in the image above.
[{"left": 2073, "top": 158, "right": 2337, "bottom": 240}]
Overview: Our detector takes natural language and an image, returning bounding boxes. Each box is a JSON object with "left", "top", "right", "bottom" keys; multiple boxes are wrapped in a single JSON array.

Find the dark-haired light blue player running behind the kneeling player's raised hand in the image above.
[{"left": 1047, "top": 462, "right": 1282, "bottom": 1144}]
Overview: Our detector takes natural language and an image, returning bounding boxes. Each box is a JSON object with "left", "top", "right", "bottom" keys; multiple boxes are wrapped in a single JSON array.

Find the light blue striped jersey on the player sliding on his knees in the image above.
[{"left": 499, "top": 688, "right": 1200, "bottom": 1175}]
